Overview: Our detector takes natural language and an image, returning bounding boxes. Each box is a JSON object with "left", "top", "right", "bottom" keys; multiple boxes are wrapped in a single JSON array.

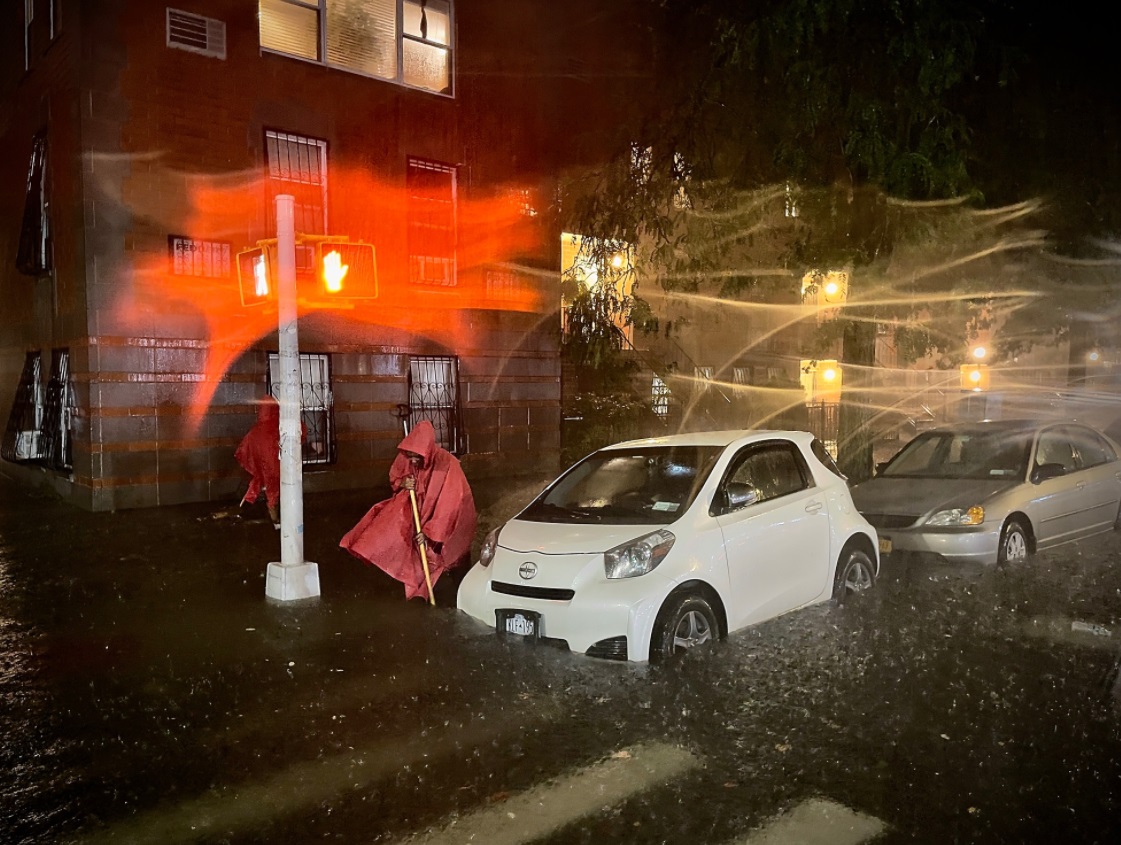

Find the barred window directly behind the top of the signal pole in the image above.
[{"left": 265, "top": 130, "right": 327, "bottom": 273}]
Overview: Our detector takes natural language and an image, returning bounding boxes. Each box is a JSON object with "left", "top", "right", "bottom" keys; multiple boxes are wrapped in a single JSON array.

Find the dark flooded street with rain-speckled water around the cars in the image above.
[{"left": 0, "top": 463, "right": 1121, "bottom": 845}]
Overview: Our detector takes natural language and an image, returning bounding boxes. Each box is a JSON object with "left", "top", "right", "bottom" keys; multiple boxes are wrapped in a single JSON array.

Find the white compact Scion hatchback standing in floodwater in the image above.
[{"left": 458, "top": 431, "right": 879, "bottom": 661}]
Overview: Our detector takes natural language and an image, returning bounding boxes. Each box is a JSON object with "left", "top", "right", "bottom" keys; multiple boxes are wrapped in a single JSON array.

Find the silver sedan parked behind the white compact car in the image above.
[{"left": 852, "top": 420, "right": 1121, "bottom": 564}]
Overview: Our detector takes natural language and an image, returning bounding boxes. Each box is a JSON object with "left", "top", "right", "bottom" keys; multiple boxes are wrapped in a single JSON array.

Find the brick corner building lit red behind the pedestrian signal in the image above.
[{"left": 0, "top": 0, "right": 641, "bottom": 510}]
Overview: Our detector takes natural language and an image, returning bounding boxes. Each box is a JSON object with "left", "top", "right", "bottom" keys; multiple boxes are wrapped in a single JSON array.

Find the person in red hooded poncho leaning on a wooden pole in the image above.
[{"left": 339, "top": 420, "right": 476, "bottom": 600}]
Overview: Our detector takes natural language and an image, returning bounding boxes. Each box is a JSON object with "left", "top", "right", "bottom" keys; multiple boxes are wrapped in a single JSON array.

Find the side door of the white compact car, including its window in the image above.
[{"left": 713, "top": 440, "right": 831, "bottom": 630}]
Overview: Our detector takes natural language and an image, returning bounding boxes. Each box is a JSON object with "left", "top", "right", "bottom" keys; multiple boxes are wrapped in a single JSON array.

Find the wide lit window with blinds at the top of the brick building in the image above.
[{"left": 257, "top": 0, "right": 454, "bottom": 94}]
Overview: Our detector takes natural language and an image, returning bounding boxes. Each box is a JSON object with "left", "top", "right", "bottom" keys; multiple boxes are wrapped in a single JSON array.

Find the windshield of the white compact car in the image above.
[{"left": 518, "top": 446, "right": 722, "bottom": 524}]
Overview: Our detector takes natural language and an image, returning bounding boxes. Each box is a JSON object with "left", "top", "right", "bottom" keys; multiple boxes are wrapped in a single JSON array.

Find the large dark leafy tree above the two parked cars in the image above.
[{"left": 571, "top": 0, "right": 1071, "bottom": 480}]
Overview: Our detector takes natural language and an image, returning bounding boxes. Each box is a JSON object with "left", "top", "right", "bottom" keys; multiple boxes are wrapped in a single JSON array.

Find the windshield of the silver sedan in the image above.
[{"left": 880, "top": 429, "right": 1031, "bottom": 480}]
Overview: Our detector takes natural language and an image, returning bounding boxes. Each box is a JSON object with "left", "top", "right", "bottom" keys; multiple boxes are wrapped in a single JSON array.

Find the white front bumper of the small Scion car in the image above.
[{"left": 456, "top": 564, "right": 674, "bottom": 662}]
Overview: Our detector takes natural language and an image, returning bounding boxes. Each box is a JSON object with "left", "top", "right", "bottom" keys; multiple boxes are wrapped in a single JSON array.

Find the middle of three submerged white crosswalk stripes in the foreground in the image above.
[{"left": 406, "top": 743, "right": 700, "bottom": 845}]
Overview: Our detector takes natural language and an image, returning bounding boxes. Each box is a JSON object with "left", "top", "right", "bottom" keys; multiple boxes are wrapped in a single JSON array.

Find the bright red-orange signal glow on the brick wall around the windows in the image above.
[{"left": 121, "top": 167, "right": 558, "bottom": 430}]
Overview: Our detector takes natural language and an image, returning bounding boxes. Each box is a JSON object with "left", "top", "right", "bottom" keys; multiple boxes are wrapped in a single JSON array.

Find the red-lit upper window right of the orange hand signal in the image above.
[{"left": 405, "top": 158, "right": 455, "bottom": 286}]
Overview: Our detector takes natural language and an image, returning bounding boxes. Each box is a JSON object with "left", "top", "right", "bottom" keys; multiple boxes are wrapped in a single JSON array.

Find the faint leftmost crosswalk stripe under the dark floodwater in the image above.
[{"left": 80, "top": 702, "right": 561, "bottom": 845}]
